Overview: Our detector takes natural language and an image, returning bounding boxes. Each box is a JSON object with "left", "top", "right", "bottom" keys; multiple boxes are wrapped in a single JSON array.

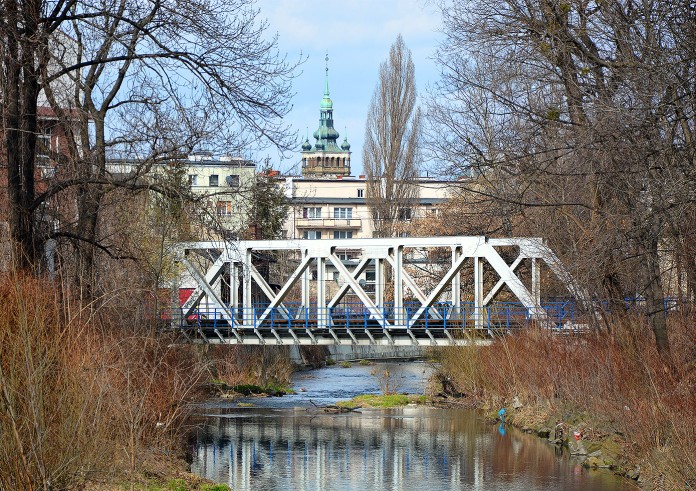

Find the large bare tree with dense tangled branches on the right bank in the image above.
[{"left": 429, "top": 0, "right": 696, "bottom": 362}]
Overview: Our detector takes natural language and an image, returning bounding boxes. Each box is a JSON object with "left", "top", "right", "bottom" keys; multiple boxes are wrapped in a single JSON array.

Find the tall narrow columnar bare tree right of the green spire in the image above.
[{"left": 363, "top": 35, "right": 421, "bottom": 237}]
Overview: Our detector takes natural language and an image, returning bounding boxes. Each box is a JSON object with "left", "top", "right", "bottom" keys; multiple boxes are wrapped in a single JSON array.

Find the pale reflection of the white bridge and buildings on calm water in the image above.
[{"left": 194, "top": 409, "right": 494, "bottom": 490}]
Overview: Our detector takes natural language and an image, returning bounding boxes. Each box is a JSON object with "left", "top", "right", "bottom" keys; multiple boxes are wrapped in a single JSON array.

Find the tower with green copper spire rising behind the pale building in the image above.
[{"left": 302, "top": 54, "right": 350, "bottom": 177}]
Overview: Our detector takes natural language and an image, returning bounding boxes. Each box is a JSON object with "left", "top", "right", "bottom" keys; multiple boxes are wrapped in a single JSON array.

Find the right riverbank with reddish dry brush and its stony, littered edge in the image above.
[{"left": 435, "top": 321, "right": 696, "bottom": 490}]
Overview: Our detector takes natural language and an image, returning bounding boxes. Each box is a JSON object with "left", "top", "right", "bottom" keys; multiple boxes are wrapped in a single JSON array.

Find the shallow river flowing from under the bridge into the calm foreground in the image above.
[{"left": 192, "top": 363, "right": 632, "bottom": 491}]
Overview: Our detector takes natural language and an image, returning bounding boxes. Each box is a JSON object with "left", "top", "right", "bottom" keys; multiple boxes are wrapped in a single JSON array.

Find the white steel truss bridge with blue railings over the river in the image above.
[{"left": 171, "top": 236, "right": 586, "bottom": 346}]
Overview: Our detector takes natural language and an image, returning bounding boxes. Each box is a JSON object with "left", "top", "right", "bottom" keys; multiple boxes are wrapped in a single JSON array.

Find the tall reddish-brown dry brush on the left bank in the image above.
[{"left": 0, "top": 275, "right": 206, "bottom": 490}]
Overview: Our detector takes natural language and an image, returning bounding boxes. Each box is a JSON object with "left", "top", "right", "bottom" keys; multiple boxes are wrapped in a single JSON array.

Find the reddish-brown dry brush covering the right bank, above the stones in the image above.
[{"left": 443, "top": 316, "right": 696, "bottom": 489}]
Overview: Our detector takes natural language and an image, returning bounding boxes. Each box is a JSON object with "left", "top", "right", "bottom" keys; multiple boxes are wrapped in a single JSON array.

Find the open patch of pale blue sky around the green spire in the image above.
[{"left": 257, "top": 0, "right": 442, "bottom": 176}]
